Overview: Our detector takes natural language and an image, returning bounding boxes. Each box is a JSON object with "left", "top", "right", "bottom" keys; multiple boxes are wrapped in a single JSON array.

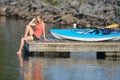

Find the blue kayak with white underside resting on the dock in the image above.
[{"left": 50, "top": 29, "right": 120, "bottom": 41}]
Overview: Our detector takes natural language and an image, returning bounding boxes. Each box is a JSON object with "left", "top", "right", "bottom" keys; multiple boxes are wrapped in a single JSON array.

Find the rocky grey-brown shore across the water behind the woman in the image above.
[{"left": 0, "top": 0, "right": 120, "bottom": 28}]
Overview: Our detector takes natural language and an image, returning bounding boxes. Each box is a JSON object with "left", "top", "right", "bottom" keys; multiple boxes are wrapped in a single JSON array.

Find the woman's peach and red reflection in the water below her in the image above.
[{"left": 18, "top": 55, "right": 44, "bottom": 80}]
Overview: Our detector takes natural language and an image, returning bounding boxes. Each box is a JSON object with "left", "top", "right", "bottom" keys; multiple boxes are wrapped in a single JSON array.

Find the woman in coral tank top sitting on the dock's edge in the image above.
[{"left": 17, "top": 16, "right": 46, "bottom": 54}]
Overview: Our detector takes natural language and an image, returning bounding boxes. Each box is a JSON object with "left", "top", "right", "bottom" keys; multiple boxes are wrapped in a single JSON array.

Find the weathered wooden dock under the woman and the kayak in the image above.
[{"left": 26, "top": 37, "right": 120, "bottom": 58}]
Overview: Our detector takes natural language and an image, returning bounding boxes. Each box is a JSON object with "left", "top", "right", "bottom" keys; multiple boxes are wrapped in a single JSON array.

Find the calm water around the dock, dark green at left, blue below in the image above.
[{"left": 0, "top": 17, "right": 120, "bottom": 80}]
